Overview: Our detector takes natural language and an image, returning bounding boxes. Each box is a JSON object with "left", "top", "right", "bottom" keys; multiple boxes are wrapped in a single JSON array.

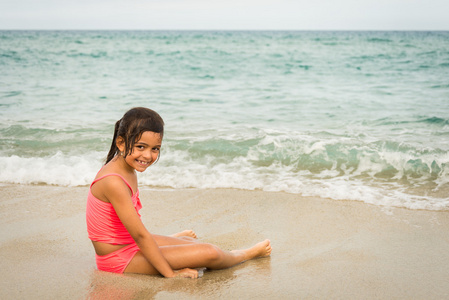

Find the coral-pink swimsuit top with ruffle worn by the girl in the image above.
[{"left": 86, "top": 173, "right": 142, "bottom": 245}]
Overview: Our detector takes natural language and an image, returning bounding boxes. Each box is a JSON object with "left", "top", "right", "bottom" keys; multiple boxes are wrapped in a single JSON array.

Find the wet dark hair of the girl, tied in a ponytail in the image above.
[{"left": 105, "top": 107, "right": 164, "bottom": 164}]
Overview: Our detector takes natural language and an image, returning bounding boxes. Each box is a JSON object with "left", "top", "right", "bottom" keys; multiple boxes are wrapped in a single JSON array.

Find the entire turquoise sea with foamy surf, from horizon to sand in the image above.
[{"left": 0, "top": 31, "right": 449, "bottom": 210}]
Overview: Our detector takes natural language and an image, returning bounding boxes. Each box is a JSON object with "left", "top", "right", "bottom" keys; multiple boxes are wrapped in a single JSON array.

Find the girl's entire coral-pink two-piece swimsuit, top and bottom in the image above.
[{"left": 86, "top": 173, "right": 142, "bottom": 273}]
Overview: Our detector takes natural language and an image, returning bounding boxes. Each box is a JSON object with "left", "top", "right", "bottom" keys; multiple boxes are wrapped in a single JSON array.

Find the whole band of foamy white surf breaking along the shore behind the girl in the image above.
[{"left": 0, "top": 132, "right": 449, "bottom": 210}]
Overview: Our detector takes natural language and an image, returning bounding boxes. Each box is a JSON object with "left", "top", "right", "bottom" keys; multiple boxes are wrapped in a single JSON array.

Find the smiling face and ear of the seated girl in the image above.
[{"left": 117, "top": 131, "right": 162, "bottom": 172}]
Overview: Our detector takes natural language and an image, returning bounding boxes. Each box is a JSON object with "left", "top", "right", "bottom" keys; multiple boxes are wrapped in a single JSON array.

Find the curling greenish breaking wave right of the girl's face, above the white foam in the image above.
[{"left": 165, "top": 132, "right": 449, "bottom": 181}]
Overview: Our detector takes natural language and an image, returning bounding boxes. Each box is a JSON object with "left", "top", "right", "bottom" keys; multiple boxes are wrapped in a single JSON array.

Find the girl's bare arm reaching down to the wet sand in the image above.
[{"left": 103, "top": 176, "right": 196, "bottom": 277}]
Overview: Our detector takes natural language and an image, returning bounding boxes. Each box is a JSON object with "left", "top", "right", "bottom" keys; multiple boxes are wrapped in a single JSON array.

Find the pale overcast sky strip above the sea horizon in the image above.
[{"left": 0, "top": 0, "right": 449, "bottom": 30}]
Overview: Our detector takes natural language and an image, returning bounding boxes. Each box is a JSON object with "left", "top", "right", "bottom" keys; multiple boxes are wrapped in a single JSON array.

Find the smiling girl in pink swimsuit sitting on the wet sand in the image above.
[{"left": 86, "top": 107, "right": 271, "bottom": 278}]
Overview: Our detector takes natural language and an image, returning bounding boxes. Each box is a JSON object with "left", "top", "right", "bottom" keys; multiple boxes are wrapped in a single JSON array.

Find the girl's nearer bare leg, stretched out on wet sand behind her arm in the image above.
[{"left": 125, "top": 240, "right": 271, "bottom": 275}]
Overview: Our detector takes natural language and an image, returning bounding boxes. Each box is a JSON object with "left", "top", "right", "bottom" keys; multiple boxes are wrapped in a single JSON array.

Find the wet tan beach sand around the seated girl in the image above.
[{"left": 0, "top": 185, "right": 449, "bottom": 299}]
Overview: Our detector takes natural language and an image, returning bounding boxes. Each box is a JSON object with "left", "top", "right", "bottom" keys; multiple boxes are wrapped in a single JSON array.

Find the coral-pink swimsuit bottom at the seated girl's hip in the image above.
[{"left": 95, "top": 243, "right": 139, "bottom": 273}]
